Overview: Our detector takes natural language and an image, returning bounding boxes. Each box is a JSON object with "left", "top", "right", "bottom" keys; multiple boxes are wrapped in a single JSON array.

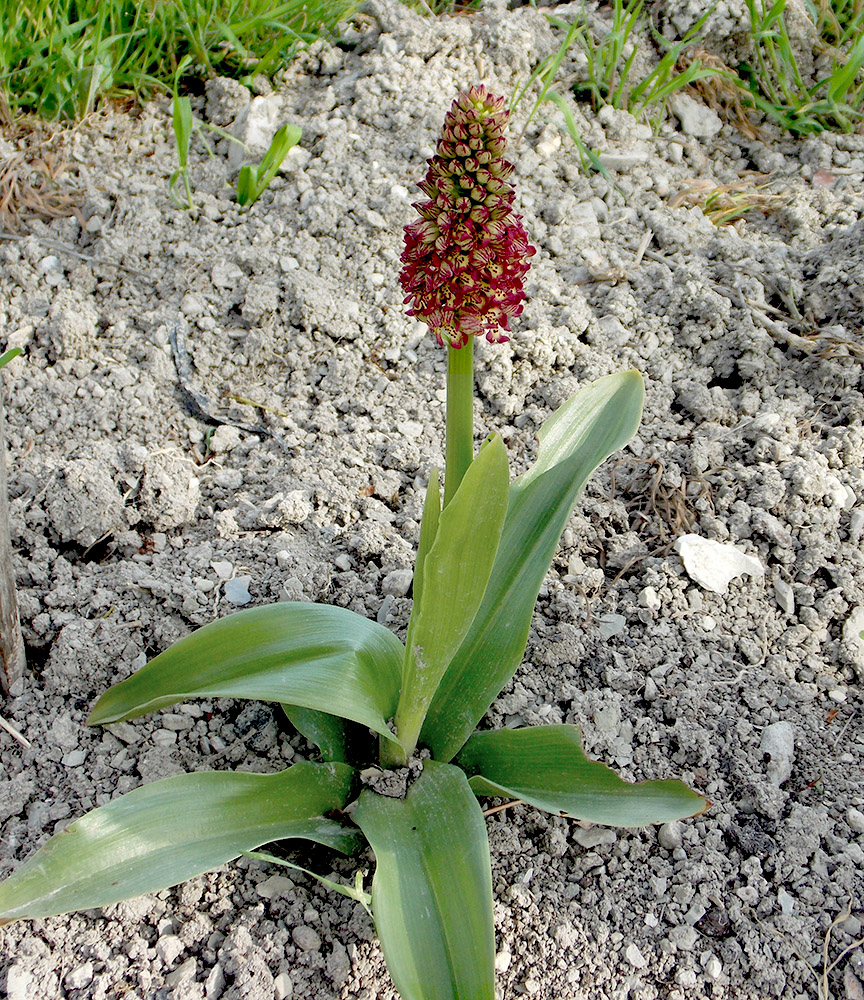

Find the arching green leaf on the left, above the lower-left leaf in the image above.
[{"left": 87, "top": 601, "right": 404, "bottom": 739}]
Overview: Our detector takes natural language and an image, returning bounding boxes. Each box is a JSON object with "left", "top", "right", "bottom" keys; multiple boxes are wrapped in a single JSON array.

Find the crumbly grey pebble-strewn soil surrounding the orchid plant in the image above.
[{"left": 0, "top": 0, "right": 864, "bottom": 1000}]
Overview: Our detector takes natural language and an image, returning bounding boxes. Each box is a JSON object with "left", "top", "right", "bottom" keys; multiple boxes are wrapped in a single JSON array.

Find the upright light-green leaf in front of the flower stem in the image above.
[{"left": 396, "top": 434, "right": 508, "bottom": 754}]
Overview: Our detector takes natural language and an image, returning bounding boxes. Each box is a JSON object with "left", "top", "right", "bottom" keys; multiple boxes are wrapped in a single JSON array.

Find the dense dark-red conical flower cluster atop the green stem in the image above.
[{"left": 399, "top": 85, "right": 536, "bottom": 347}]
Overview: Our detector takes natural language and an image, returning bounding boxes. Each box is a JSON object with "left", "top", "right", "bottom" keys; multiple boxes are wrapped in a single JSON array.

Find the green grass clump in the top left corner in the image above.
[{"left": 0, "top": 0, "right": 358, "bottom": 120}]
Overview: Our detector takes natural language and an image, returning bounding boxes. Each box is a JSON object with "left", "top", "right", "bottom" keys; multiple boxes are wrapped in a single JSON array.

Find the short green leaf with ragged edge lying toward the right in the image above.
[{"left": 456, "top": 726, "right": 709, "bottom": 826}]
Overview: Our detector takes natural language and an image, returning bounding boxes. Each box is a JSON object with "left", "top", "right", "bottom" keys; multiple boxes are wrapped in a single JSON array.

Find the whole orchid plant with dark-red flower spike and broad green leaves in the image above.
[{"left": 0, "top": 86, "right": 707, "bottom": 1000}]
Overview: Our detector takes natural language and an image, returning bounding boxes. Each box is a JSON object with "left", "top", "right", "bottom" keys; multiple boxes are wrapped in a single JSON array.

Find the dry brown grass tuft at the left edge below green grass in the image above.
[{"left": 0, "top": 147, "right": 85, "bottom": 233}]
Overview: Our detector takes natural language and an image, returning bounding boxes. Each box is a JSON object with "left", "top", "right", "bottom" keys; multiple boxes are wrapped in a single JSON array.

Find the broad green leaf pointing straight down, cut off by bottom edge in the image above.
[{"left": 354, "top": 760, "right": 495, "bottom": 1000}]
